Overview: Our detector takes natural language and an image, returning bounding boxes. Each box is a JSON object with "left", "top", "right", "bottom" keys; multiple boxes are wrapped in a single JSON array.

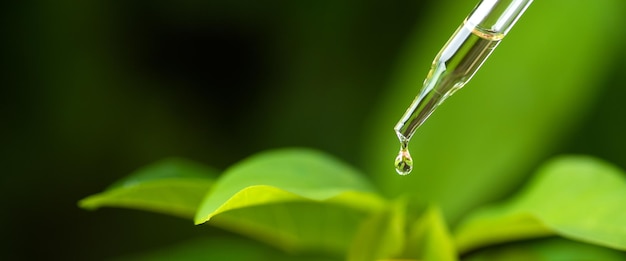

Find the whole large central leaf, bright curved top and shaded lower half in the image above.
[{"left": 190, "top": 149, "right": 385, "bottom": 254}]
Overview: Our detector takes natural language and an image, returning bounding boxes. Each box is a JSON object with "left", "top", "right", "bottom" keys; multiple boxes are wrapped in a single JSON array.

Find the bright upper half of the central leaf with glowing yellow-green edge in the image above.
[{"left": 195, "top": 146, "right": 384, "bottom": 224}]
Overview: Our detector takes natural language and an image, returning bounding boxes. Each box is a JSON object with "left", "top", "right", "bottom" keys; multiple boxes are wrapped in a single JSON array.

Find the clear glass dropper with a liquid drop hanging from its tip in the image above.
[{"left": 394, "top": 0, "right": 532, "bottom": 175}]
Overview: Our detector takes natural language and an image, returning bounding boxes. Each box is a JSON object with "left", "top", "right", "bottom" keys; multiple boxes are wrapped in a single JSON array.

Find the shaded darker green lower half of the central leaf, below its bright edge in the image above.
[{"left": 209, "top": 200, "right": 369, "bottom": 253}]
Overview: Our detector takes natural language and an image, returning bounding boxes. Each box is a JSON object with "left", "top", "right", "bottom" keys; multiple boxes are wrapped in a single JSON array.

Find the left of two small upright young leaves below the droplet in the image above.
[{"left": 348, "top": 200, "right": 406, "bottom": 261}]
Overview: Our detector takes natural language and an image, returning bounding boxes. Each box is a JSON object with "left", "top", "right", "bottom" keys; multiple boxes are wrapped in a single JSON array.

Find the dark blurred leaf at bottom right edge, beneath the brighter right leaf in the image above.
[{"left": 464, "top": 238, "right": 626, "bottom": 261}]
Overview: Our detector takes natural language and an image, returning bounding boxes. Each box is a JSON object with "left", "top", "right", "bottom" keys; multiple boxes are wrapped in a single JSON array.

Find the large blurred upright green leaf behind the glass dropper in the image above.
[{"left": 362, "top": 0, "right": 626, "bottom": 222}]
